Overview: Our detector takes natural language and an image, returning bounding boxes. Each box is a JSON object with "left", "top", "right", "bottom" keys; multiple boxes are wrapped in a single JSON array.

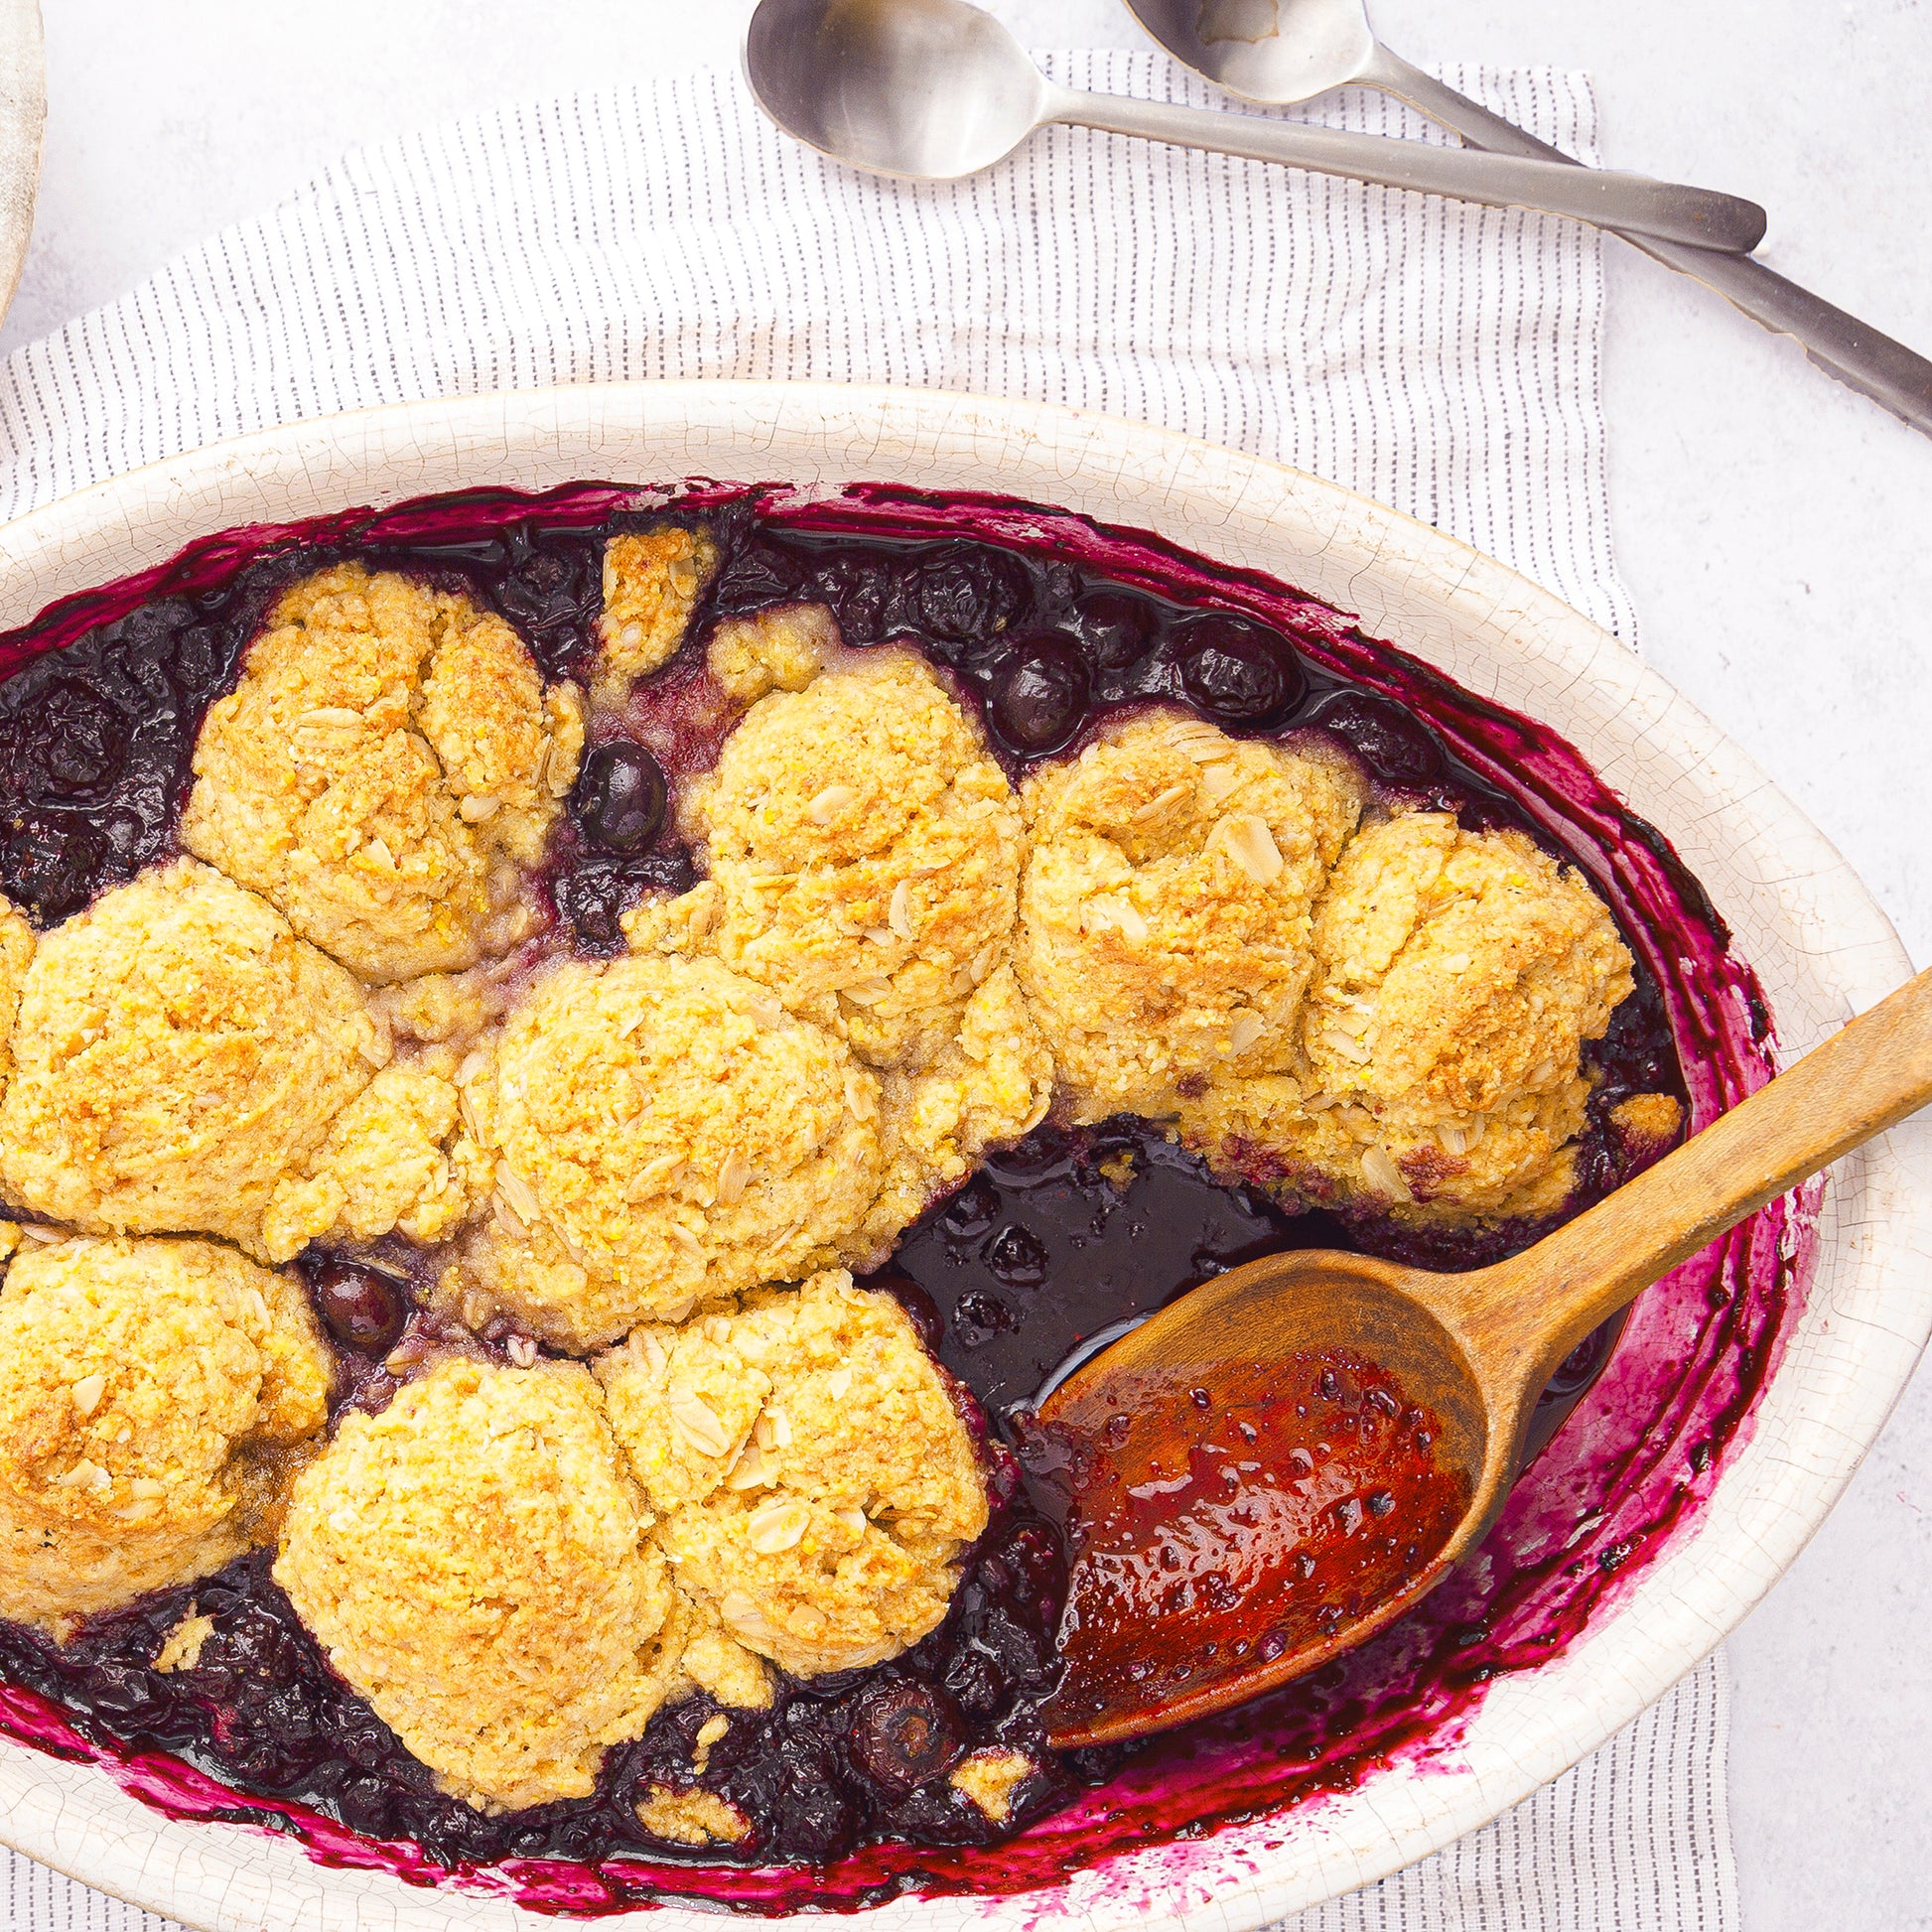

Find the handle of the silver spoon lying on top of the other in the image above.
[{"left": 1041, "top": 87, "right": 1764, "bottom": 253}]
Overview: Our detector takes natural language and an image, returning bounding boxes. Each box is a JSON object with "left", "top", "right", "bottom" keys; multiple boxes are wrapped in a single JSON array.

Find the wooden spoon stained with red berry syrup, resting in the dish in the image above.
[{"left": 1022, "top": 972, "right": 1932, "bottom": 1748}]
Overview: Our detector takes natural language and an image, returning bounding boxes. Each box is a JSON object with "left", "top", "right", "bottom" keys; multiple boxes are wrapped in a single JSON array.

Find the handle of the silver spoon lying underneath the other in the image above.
[{"left": 1362, "top": 47, "right": 1932, "bottom": 435}]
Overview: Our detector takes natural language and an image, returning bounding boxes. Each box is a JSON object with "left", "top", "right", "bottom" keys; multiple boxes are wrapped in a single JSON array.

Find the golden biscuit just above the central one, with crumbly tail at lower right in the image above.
[{"left": 648, "top": 648, "right": 1053, "bottom": 1264}]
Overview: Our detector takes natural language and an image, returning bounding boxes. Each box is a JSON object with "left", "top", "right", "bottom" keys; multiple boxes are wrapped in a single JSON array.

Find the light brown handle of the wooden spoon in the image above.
[{"left": 1444, "top": 970, "right": 1932, "bottom": 1397}]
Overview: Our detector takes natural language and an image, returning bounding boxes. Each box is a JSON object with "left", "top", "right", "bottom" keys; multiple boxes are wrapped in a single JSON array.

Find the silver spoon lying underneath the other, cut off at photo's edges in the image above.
[{"left": 1127, "top": 0, "right": 1932, "bottom": 435}]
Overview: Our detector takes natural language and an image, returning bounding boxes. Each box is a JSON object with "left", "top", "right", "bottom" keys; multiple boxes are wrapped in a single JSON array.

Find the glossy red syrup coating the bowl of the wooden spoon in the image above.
[{"left": 1020, "top": 1350, "right": 1470, "bottom": 1733}]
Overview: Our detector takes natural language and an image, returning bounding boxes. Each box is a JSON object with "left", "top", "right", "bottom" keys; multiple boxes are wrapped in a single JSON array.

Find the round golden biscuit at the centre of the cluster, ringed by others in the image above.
[{"left": 462, "top": 954, "right": 885, "bottom": 1348}]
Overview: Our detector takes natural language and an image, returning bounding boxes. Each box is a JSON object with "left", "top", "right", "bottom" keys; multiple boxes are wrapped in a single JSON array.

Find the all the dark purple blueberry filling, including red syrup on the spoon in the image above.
[{"left": 0, "top": 483, "right": 1810, "bottom": 1914}]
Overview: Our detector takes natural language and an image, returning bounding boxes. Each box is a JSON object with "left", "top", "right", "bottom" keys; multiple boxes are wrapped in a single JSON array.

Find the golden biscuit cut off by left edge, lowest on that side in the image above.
[{"left": 0, "top": 1236, "right": 331, "bottom": 1632}]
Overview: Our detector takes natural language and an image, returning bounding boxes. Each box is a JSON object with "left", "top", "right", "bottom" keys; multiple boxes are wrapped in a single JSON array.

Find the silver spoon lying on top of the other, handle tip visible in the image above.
[{"left": 744, "top": 0, "right": 1764, "bottom": 251}]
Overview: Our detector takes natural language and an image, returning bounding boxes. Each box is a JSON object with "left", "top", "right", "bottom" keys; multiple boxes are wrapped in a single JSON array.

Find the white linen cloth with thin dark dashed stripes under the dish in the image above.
[{"left": 0, "top": 53, "right": 1738, "bottom": 1932}]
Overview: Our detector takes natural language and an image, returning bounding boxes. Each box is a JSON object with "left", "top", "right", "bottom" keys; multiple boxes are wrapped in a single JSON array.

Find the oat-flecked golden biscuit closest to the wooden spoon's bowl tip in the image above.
[{"left": 597, "top": 1271, "right": 987, "bottom": 1677}]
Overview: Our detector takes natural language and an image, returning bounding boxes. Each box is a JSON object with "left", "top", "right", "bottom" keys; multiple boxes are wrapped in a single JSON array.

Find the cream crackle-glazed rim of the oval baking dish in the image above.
[{"left": 0, "top": 382, "right": 1932, "bottom": 1932}]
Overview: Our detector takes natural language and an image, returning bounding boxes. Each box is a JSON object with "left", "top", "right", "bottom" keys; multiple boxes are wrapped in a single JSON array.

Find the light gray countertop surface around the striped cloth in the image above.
[{"left": 18, "top": 0, "right": 1932, "bottom": 1932}]
